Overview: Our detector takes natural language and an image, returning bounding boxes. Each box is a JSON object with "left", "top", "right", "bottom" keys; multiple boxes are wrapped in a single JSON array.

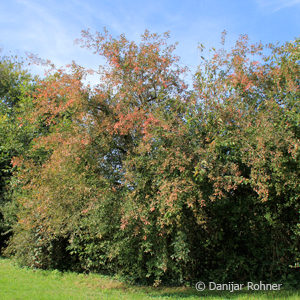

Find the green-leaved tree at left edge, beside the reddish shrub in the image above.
[{"left": 0, "top": 56, "right": 35, "bottom": 251}]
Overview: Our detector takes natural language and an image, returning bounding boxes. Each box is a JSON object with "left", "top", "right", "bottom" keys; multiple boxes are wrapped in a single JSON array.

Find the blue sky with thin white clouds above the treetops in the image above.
[{"left": 0, "top": 0, "right": 300, "bottom": 81}]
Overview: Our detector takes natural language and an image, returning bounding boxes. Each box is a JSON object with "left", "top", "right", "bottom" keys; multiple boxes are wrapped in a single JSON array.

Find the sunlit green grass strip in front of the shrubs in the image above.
[{"left": 0, "top": 258, "right": 300, "bottom": 300}]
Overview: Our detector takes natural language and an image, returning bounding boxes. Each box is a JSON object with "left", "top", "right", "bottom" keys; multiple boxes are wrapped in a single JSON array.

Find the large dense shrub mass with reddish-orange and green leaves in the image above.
[{"left": 0, "top": 31, "right": 300, "bottom": 285}]
